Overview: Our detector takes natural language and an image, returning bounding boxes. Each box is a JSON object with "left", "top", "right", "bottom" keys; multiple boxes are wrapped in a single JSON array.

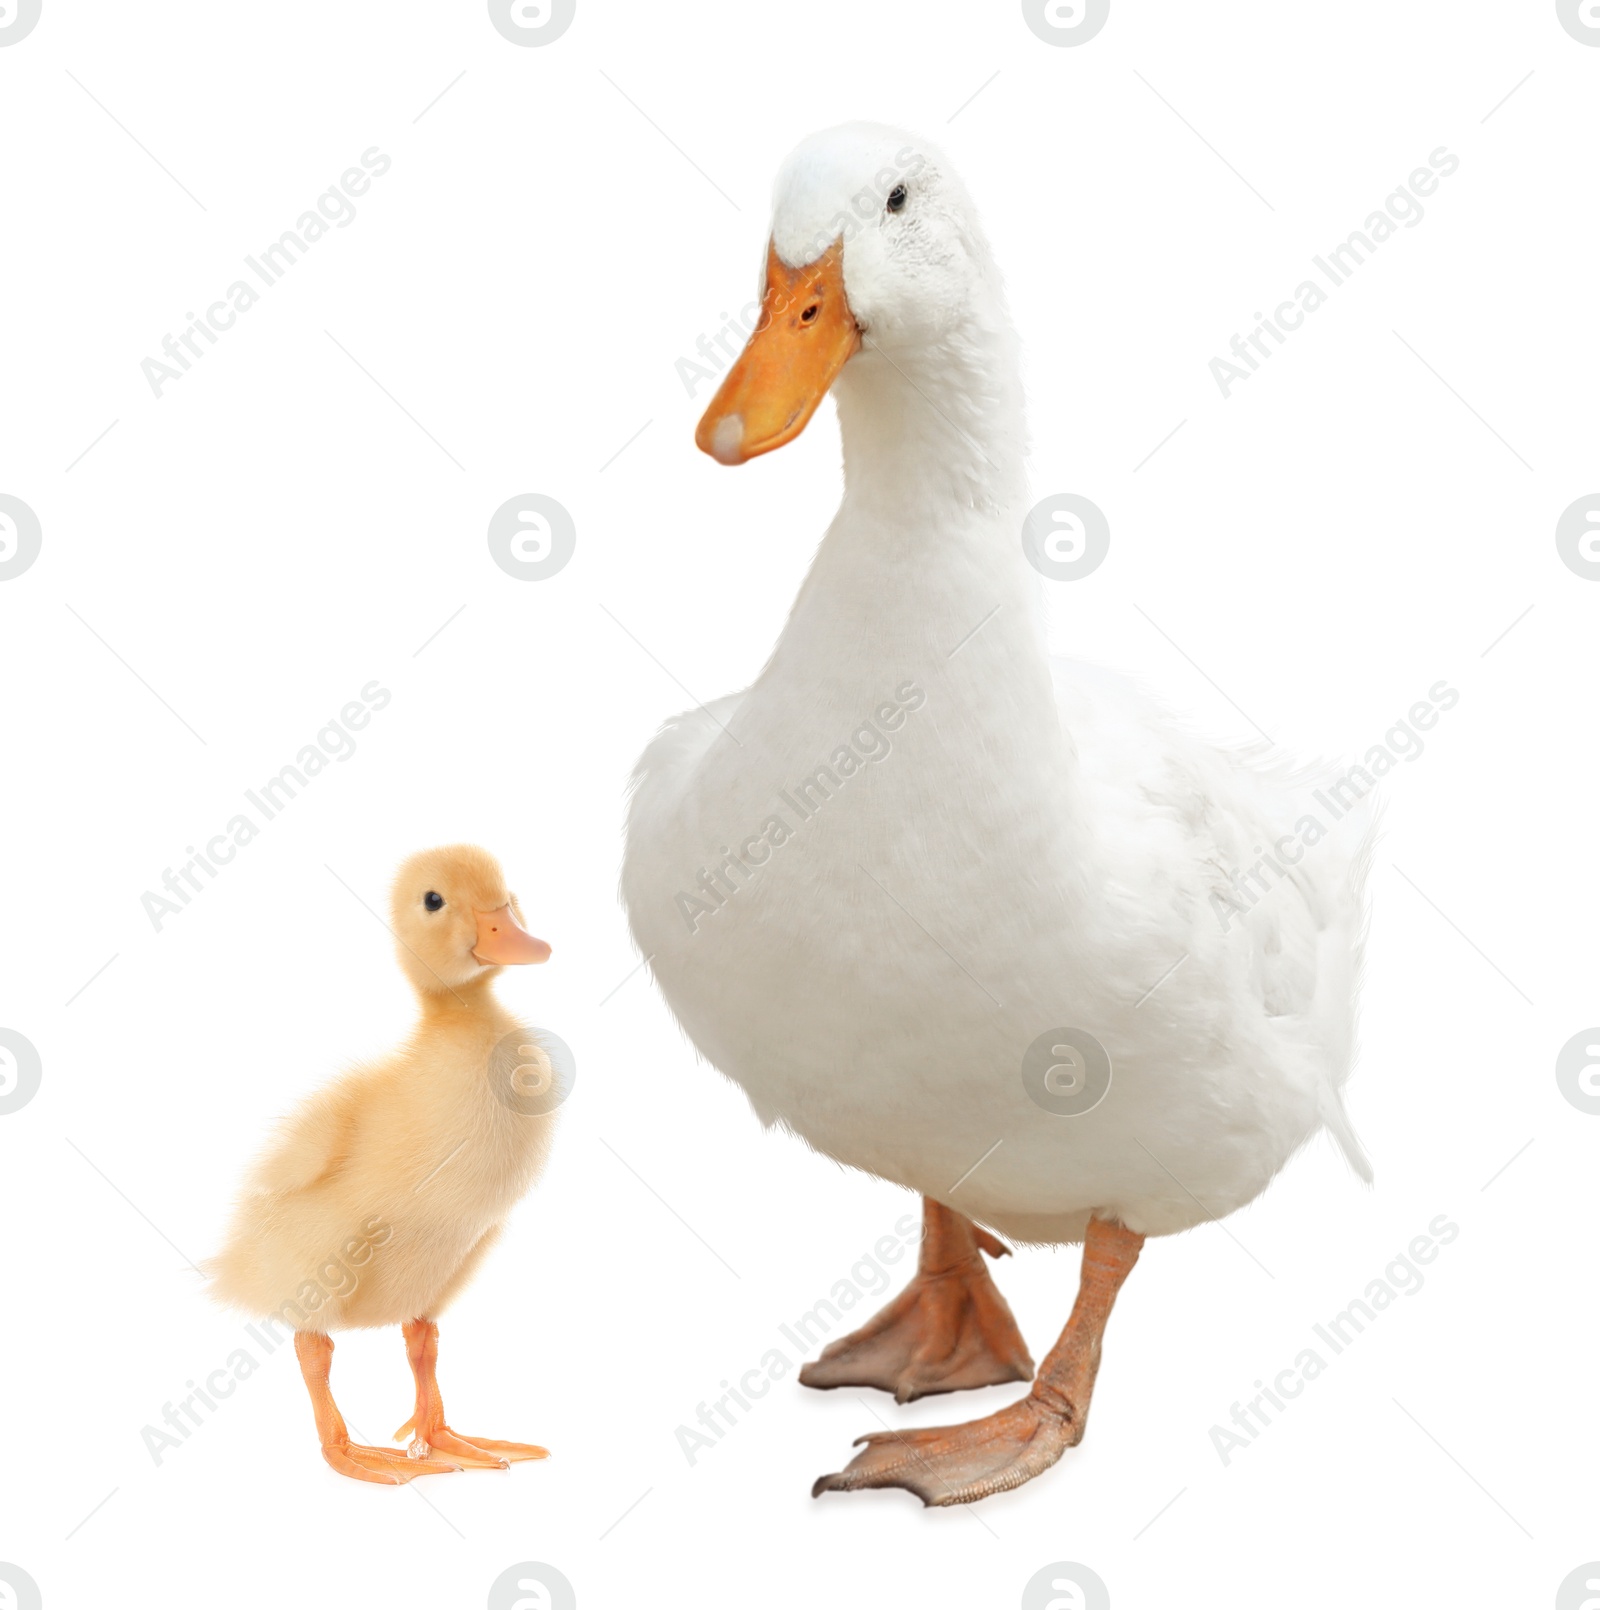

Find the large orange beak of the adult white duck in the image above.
[{"left": 694, "top": 240, "right": 861, "bottom": 464}]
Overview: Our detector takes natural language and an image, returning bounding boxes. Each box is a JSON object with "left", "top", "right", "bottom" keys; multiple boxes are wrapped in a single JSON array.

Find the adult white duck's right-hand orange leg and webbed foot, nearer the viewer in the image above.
[{"left": 811, "top": 1219, "right": 1144, "bottom": 1505}]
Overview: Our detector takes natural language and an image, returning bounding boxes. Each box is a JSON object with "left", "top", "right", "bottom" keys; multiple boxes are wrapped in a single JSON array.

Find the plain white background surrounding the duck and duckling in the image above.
[{"left": 0, "top": 0, "right": 1600, "bottom": 1610}]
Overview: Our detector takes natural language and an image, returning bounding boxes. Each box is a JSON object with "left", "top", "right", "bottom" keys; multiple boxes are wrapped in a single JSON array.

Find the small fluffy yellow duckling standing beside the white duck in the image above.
[{"left": 209, "top": 844, "right": 563, "bottom": 1484}]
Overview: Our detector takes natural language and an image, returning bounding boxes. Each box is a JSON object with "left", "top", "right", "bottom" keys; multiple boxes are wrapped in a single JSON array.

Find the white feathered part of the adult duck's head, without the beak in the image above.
[{"left": 773, "top": 122, "right": 996, "bottom": 348}]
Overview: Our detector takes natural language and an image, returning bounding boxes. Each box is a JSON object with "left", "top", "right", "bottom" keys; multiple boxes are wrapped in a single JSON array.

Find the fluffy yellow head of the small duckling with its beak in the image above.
[{"left": 390, "top": 844, "right": 549, "bottom": 995}]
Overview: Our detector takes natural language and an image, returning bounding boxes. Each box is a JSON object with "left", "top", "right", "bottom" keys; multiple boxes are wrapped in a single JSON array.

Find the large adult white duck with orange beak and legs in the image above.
[{"left": 623, "top": 124, "right": 1370, "bottom": 1504}]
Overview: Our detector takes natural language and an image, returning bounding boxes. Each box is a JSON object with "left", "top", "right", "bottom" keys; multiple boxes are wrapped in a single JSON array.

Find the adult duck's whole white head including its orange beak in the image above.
[{"left": 695, "top": 122, "right": 1009, "bottom": 464}]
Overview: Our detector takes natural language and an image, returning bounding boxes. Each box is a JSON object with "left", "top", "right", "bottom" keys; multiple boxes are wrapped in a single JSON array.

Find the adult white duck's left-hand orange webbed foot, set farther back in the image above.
[{"left": 800, "top": 1196, "right": 1033, "bottom": 1404}]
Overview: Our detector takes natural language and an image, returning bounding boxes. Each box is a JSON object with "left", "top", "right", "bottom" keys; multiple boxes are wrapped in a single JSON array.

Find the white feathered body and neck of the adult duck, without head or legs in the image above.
[{"left": 623, "top": 122, "right": 1368, "bottom": 1241}]
